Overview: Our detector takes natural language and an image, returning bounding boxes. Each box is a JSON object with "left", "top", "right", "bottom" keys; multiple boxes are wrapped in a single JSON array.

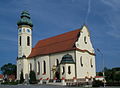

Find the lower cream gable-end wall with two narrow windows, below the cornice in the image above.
[{"left": 76, "top": 51, "right": 96, "bottom": 78}]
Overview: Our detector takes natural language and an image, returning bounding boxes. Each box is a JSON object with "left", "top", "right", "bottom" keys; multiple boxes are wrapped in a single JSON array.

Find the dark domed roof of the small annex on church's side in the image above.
[{"left": 61, "top": 54, "right": 75, "bottom": 64}]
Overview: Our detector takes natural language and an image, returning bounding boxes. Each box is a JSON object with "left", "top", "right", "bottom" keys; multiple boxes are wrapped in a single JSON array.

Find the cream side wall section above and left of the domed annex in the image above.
[{"left": 50, "top": 51, "right": 75, "bottom": 79}]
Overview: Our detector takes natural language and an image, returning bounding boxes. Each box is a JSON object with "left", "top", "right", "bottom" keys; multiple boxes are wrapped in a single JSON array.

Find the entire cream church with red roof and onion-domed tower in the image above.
[{"left": 17, "top": 11, "right": 96, "bottom": 81}]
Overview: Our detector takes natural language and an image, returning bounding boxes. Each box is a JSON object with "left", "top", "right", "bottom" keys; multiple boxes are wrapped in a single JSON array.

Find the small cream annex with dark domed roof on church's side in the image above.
[{"left": 60, "top": 54, "right": 75, "bottom": 79}]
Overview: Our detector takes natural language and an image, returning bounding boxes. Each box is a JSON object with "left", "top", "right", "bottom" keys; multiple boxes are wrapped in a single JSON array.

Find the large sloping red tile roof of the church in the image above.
[{"left": 28, "top": 29, "right": 94, "bottom": 58}]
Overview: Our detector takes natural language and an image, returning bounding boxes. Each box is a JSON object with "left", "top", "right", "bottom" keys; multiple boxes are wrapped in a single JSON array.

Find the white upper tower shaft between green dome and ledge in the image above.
[{"left": 18, "top": 27, "right": 32, "bottom": 57}]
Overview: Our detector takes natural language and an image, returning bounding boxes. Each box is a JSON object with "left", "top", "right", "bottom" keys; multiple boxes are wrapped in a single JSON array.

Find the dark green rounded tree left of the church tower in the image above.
[{"left": 1, "top": 63, "right": 17, "bottom": 77}]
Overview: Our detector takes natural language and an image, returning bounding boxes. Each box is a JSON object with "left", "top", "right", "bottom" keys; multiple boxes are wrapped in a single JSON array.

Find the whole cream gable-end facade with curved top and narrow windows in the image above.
[{"left": 76, "top": 26, "right": 96, "bottom": 78}]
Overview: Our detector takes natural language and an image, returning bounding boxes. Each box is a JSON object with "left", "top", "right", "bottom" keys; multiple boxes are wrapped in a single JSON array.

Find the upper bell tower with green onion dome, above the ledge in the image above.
[{"left": 17, "top": 11, "right": 33, "bottom": 58}]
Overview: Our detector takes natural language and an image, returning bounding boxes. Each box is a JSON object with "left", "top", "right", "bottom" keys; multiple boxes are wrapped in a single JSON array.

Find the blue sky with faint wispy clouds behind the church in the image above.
[{"left": 0, "top": 0, "right": 120, "bottom": 71}]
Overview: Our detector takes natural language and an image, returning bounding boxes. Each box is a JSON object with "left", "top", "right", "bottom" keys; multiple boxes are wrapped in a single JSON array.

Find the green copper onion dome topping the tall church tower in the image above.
[{"left": 17, "top": 11, "right": 33, "bottom": 27}]
